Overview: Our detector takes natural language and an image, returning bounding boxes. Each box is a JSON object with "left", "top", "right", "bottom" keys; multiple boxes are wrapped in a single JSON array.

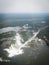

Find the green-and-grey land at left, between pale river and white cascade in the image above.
[{"left": 0, "top": 31, "right": 16, "bottom": 48}]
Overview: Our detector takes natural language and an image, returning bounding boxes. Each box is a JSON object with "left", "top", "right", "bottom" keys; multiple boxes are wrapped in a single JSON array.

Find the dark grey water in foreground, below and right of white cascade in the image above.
[{"left": 11, "top": 41, "right": 49, "bottom": 65}]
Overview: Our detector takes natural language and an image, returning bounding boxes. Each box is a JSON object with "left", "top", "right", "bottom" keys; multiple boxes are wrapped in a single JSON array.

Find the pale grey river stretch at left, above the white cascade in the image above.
[{"left": 0, "top": 26, "right": 22, "bottom": 34}]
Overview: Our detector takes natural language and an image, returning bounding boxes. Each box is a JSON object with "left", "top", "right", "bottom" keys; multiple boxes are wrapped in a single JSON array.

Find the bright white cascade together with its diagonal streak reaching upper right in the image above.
[{"left": 4, "top": 31, "right": 39, "bottom": 57}]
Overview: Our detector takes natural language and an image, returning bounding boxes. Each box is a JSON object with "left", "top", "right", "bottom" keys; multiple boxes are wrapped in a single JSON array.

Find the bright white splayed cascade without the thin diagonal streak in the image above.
[{"left": 4, "top": 33, "right": 23, "bottom": 57}]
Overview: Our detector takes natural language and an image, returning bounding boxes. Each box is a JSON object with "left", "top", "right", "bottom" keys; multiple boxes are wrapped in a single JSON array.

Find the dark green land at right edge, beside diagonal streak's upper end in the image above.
[{"left": 37, "top": 27, "right": 49, "bottom": 46}]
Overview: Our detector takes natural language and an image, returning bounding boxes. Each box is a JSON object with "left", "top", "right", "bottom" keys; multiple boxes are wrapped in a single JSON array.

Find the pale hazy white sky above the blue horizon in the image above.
[{"left": 0, "top": 0, "right": 49, "bottom": 13}]
